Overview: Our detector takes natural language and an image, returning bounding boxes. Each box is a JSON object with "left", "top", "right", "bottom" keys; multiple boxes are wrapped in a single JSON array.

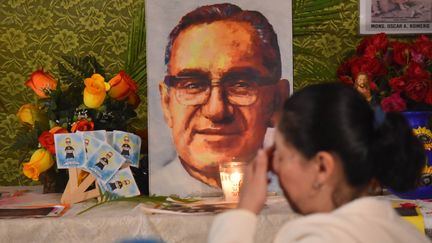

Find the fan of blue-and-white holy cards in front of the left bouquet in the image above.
[{"left": 54, "top": 130, "right": 141, "bottom": 197}]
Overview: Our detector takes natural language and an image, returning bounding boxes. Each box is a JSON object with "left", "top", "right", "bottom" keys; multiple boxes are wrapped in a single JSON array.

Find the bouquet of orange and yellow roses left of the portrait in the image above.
[{"left": 14, "top": 56, "right": 140, "bottom": 192}]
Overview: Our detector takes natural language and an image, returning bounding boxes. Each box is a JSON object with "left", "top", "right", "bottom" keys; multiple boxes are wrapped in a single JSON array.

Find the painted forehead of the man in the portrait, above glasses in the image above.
[{"left": 168, "top": 20, "right": 263, "bottom": 73}]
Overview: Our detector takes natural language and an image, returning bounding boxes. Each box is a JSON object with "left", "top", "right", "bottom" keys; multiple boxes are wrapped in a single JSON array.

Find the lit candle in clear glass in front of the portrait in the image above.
[{"left": 219, "top": 161, "right": 247, "bottom": 202}]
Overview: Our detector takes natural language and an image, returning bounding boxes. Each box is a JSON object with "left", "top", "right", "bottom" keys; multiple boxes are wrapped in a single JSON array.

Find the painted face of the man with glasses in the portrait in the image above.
[{"left": 161, "top": 21, "right": 276, "bottom": 184}]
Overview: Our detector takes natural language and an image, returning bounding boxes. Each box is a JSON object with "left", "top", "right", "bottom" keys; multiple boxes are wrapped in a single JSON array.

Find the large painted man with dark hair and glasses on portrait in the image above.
[{"left": 148, "top": 2, "right": 291, "bottom": 196}]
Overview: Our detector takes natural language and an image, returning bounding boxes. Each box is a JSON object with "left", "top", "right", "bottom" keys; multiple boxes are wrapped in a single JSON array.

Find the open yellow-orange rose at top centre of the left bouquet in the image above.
[{"left": 84, "top": 73, "right": 109, "bottom": 109}]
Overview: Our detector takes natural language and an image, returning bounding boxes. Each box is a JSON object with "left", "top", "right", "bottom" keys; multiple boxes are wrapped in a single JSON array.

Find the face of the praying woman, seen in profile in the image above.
[{"left": 272, "top": 131, "right": 314, "bottom": 214}]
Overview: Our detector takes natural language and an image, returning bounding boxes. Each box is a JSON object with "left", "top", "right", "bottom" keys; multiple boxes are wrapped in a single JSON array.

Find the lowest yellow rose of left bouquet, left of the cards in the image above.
[{"left": 23, "top": 148, "right": 54, "bottom": 181}]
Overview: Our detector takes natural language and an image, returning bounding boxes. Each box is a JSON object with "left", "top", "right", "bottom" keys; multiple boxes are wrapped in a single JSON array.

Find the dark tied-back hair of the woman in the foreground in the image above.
[{"left": 278, "top": 83, "right": 426, "bottom": 192}]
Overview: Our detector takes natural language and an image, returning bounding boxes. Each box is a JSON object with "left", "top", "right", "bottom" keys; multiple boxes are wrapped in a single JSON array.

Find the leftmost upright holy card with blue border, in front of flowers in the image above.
[{"left": 54, "top": 133, "right": 85, "bottom": 169}]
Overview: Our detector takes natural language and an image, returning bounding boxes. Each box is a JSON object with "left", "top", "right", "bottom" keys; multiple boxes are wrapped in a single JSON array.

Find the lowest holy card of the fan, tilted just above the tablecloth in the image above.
[{"left": 104, "top": 166, "right": 140, "bottom": 197}]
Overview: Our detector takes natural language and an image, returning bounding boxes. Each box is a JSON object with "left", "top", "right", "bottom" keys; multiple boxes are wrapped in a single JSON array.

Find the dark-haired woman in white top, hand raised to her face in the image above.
[{"left": 209, "top": 83, "right": 429, "bottom": 243}]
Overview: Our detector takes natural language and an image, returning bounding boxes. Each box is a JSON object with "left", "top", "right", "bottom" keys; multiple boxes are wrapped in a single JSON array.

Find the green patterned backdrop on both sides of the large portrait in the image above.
[{"left": 0, "top": 0, "right": 426, "bottom": 185}]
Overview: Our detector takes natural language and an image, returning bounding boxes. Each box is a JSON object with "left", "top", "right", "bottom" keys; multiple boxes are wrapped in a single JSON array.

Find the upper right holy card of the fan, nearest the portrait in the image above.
[{"left": 113, "top": 131, "right": 141, "bottom": 167}]
